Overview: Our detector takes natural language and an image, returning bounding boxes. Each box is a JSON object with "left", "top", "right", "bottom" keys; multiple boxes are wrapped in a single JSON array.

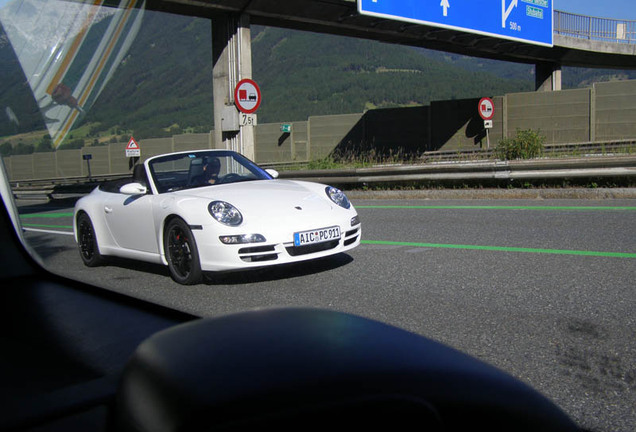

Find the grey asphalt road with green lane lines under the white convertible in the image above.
[{"left": 21, "top": 199, "right": 636, "bottom": 432}]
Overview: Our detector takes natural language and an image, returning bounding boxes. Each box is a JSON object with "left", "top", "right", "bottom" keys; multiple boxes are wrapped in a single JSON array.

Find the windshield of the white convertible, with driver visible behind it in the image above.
[{"left": 148, "top": 151, "right": 272, "bottom": 193}]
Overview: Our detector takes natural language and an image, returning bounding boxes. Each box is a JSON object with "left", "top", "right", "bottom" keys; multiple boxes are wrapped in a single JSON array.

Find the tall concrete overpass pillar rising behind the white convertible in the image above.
[{"left": 212, "top": 14, "right": 255, "bottom": 160}]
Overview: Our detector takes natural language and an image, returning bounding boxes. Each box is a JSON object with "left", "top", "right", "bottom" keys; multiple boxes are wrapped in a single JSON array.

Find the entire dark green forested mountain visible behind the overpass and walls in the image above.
[{"left": 0, "top": 11, "right": 636, "bottom": 139}]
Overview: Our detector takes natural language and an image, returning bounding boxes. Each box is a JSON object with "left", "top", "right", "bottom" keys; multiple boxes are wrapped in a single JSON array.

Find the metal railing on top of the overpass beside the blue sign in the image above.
[{"left": 554, "top": 10, "right": 636, "bottom": 44}]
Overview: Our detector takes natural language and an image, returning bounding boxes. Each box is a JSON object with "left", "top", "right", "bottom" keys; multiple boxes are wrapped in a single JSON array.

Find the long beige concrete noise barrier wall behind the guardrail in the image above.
[{"left": 4, "top": 80, "right": 636, "bottom": 181}]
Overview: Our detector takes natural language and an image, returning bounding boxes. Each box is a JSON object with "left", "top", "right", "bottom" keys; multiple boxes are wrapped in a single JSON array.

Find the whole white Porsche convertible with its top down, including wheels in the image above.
[{"left": 74, "top": 150, "right": 361, "bottom": 285}]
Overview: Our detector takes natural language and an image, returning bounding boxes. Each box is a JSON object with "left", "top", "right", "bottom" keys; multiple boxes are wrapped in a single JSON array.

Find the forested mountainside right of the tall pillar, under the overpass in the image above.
[{"left": 252, "top": 28, "right": 531, "bottom": 121}]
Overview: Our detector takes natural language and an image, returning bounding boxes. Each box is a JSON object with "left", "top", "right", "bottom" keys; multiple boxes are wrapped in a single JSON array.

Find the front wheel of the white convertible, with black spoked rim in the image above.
[{"left": 163, "top": 218, "right": 203, "bottom": 285}]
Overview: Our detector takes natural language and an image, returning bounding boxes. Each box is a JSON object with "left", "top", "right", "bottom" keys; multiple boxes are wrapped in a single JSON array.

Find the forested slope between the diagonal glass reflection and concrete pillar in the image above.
[{"left": 85, "top": 12, "right": 213, "bottom": 138}]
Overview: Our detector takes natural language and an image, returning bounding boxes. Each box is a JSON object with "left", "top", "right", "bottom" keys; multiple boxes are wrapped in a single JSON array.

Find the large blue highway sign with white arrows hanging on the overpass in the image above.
[{"left": 358, "top": 0, "right": 552, "bottom": 46}]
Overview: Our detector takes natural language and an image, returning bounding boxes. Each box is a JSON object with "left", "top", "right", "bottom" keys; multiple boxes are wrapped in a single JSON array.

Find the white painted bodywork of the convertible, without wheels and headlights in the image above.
[{"left": 74, "top": 150, "right": 361, "bottom": 284}]
